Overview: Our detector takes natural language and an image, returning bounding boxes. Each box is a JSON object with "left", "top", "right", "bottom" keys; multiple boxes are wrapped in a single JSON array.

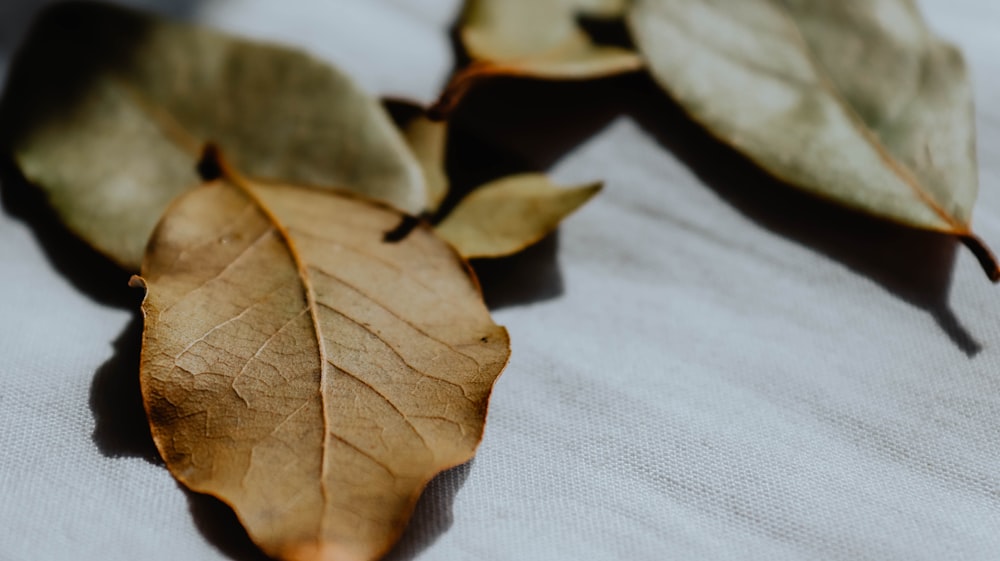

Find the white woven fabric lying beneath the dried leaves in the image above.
[{"left": 0, "top": 0, "right": 1000, "bottom": 561}]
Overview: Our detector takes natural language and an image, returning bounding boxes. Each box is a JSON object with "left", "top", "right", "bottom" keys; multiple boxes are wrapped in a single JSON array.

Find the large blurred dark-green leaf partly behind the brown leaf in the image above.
[{"left": 0, "top": 3, "right": 426, "bottom": 269}]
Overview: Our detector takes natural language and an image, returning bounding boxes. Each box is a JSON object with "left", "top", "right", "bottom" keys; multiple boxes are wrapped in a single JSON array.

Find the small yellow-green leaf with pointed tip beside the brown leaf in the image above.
[{"left": 436, "top": 173, "right": 601, "bottom": 259}]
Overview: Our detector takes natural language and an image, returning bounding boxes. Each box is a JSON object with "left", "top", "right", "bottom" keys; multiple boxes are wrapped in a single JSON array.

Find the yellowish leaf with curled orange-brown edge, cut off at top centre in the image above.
[{"left": 431, "top": 0, "right": 642, "bottom": 115}]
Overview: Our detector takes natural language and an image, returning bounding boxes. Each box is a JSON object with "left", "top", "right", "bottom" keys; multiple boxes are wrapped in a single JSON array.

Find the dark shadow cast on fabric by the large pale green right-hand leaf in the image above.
[{"left": 618, "top": 75, "right": 982, "bottom": 358}]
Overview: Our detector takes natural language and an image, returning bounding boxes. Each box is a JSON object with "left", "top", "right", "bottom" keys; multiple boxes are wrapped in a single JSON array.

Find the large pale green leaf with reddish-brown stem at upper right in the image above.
[{"left": 628, "top": 0, "right": 1000, "bottom": 281}]
